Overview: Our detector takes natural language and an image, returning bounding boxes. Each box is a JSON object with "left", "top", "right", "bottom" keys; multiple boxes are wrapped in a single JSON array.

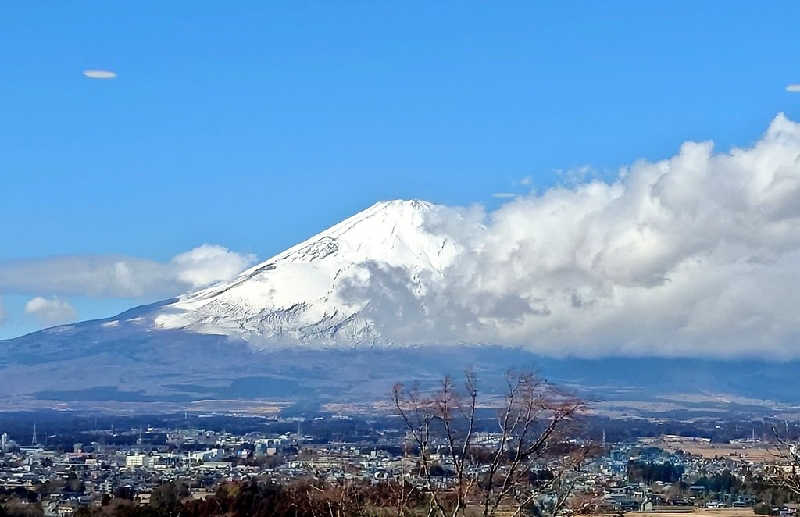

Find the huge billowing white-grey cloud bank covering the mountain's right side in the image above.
[{"left": 344, "top": 114, "right": 800, "bottom": 358}]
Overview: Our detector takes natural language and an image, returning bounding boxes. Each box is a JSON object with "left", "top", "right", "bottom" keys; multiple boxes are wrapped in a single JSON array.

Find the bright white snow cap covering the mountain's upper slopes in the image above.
[{"left": 154, "top": 200, "right": 460, "bottom": 348}]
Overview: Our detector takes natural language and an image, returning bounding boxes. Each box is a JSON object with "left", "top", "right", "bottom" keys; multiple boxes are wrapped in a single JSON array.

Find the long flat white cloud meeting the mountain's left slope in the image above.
[{"left": 0, "top": 244, "right": 255, "bottom": 298}]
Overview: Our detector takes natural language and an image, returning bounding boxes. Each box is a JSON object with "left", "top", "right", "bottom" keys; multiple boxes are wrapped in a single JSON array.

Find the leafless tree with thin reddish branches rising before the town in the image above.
[{"left": 393, "top": 372, "right": 583, "bottom": 517}]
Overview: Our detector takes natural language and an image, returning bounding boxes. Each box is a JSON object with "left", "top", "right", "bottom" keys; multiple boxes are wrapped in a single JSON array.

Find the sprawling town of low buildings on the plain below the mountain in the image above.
[{"left": 0, "top": 415, "right": 797, "bottom": 517}]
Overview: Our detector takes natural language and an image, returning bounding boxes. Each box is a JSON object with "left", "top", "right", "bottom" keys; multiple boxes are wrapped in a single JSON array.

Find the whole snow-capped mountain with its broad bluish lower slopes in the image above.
[{"left": 0, "top": 200, "right": 800, "bottom": 409}]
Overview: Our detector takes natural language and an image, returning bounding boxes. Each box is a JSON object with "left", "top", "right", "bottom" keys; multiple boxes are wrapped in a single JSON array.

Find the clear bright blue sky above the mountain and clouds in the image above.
[{"left": 0, "top": 1, "right": 800, "bottom": 338}]
